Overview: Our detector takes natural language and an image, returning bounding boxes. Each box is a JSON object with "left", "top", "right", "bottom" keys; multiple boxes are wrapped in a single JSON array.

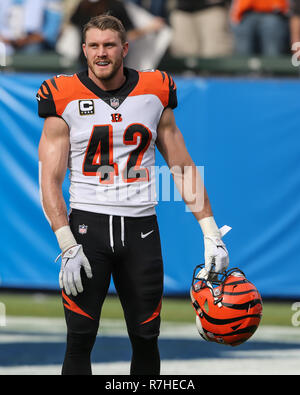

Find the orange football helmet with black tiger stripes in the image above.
[{"left": 190, "top": 265, "right": 262, "bottom": 346}]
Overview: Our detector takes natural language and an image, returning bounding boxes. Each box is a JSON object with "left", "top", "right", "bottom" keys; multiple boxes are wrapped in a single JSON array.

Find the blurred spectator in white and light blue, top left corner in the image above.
[{"left": 0, "top": 0, "right": 63, "bottom": 55}]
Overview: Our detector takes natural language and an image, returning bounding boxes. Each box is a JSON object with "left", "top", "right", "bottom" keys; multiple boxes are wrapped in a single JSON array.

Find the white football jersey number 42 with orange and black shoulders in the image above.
[{"left": 37, "top": 68, "right": 177, "bottom": 217}]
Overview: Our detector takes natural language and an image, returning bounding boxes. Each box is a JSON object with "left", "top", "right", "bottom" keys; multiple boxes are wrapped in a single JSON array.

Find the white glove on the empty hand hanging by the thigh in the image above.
[{"left": 57, "top": 244, "right": 93, "bottom": 296}]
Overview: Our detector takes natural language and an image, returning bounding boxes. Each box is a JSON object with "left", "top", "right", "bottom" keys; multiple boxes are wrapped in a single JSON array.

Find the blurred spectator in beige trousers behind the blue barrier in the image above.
[{"left": 170, "top": 0, "right": 232, "bottom": 57}]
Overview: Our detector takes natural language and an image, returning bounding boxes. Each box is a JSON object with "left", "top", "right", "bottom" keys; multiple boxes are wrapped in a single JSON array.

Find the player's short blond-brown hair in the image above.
[{"left": 83, "top": 14, "right": 127, "bottom": 44}]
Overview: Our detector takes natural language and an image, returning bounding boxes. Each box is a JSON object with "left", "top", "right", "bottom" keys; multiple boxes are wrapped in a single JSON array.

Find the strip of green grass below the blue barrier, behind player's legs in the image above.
[{"left": 0, "top": 293, "right": 293, "bottom": 326}]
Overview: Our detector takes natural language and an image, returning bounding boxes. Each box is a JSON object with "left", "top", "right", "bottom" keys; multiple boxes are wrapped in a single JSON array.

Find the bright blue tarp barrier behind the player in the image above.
[{"left": 0, "top": 73, "right": 300, "bottom": 298}]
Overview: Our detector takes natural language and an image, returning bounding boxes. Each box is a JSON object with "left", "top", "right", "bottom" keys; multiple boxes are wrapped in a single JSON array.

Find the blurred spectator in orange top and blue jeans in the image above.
[{"left": 231, "top": 0, "right": 290, "bottom": 56}]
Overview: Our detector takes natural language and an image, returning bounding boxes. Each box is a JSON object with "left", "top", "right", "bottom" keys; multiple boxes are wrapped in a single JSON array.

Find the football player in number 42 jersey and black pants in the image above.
[{"left": 37, "top": 15, "right": 228, "bottom": 375}]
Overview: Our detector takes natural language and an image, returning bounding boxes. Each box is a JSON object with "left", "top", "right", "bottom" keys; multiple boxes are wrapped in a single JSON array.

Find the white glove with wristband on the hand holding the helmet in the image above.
[{"left": 199, "top": 217, "right": 231, "bottom": 279}]
